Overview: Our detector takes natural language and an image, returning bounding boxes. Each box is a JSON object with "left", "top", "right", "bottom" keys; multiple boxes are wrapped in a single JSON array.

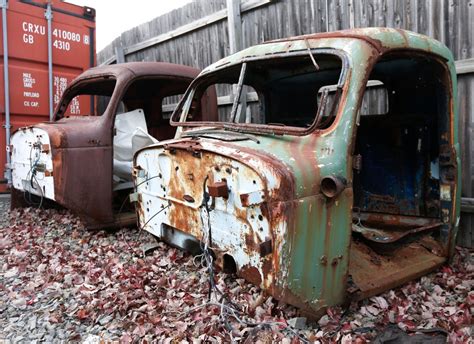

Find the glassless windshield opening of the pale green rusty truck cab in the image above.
[{"left": 172, "top": 51, "right": 344, "bottom": 135}]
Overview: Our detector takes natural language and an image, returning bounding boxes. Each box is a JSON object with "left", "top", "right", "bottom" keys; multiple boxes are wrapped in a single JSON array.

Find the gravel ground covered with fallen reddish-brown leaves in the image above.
[{"left": 0, "top": 203, "right": 474, "bottom": 343}]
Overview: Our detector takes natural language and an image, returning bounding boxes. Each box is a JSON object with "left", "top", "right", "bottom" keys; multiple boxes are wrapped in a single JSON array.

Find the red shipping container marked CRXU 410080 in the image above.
[{"left": 0, "top": 0, "right": 96, "bottom": 192}]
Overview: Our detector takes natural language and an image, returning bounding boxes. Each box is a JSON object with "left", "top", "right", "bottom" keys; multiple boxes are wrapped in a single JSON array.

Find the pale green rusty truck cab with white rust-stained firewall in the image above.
[{"left": 134, "top": 28, "right": 460, "bottom": 315}]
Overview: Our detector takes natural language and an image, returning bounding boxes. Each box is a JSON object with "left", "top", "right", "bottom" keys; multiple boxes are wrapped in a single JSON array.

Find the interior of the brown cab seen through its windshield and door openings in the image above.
[{"left": 52, "top": 76, "right": 191, "bottom": 225}]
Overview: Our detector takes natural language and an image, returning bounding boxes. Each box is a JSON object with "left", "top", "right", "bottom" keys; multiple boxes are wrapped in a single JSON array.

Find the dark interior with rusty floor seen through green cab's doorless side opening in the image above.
[{"left": 349, "top": 52, "right": 456, "bottom": 300}]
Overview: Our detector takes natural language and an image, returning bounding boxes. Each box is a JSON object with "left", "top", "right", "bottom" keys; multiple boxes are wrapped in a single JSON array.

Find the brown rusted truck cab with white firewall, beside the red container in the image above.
[{"left": 11, "top": 62, "right": 215, "bottom": 228}]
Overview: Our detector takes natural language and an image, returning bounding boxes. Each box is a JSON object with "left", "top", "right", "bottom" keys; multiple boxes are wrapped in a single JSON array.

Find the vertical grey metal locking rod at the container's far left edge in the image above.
[{"left": 1, "top": 0, "right": 12, "bottom": 185}]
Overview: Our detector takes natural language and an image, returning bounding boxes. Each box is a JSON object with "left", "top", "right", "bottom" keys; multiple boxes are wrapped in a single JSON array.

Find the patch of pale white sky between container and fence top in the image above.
[{"left": 67, "top": 0, "right": 192, "bottom": 52}]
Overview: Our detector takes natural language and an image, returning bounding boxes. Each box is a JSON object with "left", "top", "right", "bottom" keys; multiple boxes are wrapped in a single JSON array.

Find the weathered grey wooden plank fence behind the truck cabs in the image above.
[{"left": 98, "top": 0, "right": 474, "bottom": 247}]
